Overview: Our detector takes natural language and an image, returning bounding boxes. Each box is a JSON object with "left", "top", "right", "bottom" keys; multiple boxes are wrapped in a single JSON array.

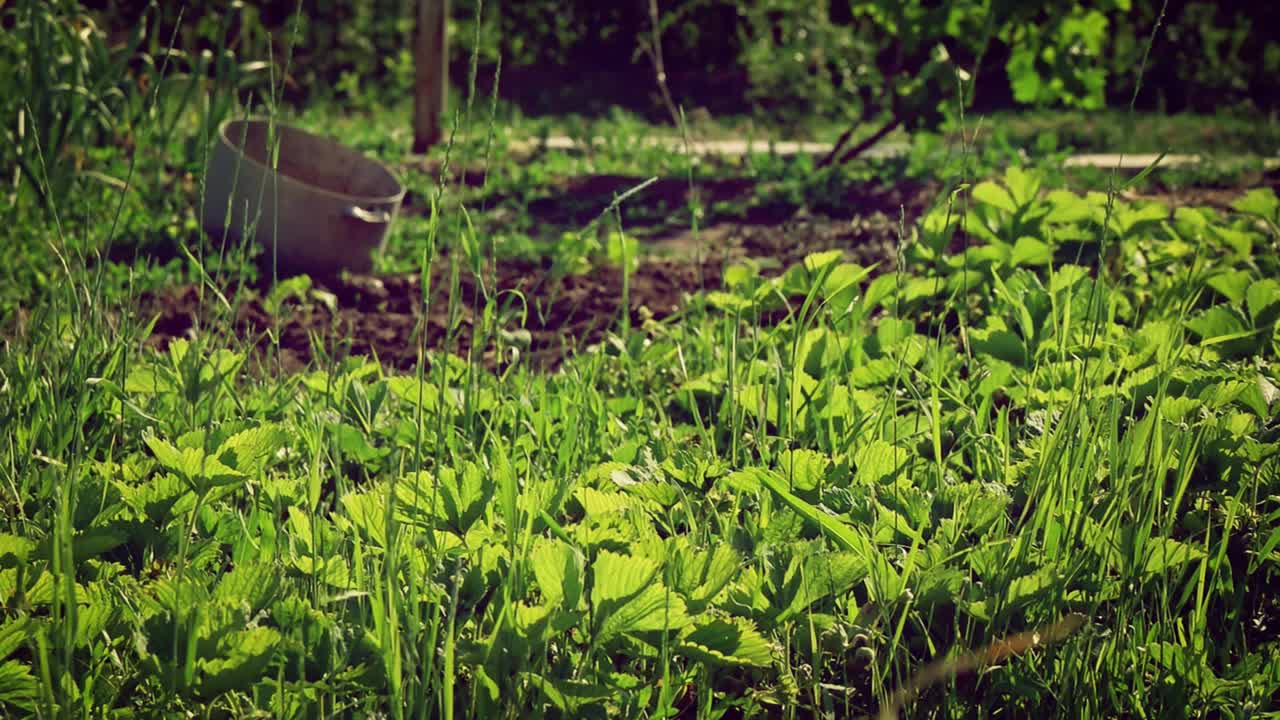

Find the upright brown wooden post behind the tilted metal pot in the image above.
[{"left": 413, "top": 0, "right": 449, "bottom": 152}]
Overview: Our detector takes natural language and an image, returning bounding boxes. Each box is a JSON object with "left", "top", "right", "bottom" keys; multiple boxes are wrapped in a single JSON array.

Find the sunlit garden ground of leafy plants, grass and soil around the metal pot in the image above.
[{"left": 0, "top": 4, "right": 1280, "bottom": 717}]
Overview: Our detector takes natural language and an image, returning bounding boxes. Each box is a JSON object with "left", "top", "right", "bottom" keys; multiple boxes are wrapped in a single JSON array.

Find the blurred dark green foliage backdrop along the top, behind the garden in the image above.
[{"left": 0, "top": 0, "right": 1280, "bottom": 207}]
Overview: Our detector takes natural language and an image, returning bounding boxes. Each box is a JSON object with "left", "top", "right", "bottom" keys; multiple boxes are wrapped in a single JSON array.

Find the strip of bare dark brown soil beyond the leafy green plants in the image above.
[{"left": 142, "top": 177, "right": 933, "bottom": 370}]
